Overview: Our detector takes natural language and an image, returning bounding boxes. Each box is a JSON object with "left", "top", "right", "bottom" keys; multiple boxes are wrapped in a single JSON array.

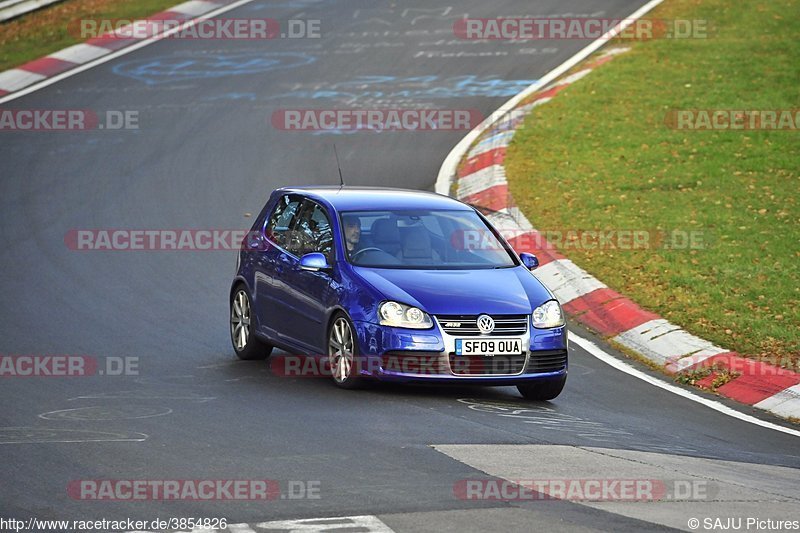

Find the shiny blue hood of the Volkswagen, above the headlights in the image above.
[{"left": 354, "top": 266, "right": 553, "bottom": 315}]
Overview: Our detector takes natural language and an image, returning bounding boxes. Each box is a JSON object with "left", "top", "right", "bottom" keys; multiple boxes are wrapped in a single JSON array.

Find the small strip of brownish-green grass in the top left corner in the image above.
[{"left": 0, "top": 0, "right": 180, "bottom": 71}]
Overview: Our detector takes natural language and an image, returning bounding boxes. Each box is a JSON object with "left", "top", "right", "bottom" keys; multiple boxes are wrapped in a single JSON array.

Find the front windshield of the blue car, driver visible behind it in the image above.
[{"left": 341, "top": 210, "right": 516, "bottom": 270}]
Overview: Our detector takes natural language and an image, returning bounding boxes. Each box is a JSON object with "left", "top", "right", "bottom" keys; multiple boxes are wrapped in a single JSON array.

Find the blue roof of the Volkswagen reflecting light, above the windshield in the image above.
[{"left": 277, "top": 186, "right": 471, "bottom": 212}]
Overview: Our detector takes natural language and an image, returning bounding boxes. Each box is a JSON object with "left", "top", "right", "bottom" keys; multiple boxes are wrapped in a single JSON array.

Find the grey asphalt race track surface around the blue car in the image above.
[{"left": 0, "top": 0, "right": 800, "bottom": 531}]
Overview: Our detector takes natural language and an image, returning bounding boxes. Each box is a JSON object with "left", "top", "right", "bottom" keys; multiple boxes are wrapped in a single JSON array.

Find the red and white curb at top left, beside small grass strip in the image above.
[{"left": 0, "top": 0, "right": 238, "bottom": 97}]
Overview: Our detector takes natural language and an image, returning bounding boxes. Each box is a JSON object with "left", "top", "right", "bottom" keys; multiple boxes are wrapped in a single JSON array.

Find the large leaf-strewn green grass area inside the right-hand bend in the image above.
[{"left": 506, "top": 0, "right": 800, "bottom": 370}]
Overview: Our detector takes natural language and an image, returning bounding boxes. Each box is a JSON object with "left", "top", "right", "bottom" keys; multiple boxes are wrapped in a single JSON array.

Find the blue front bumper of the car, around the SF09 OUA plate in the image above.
[{"left": 355, "top": 320, "right": 568, "bottom": 386}]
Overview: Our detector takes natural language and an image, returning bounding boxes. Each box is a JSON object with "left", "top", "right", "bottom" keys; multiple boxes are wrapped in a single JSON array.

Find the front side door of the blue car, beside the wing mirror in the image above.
[{"left": 283, "top": 199, "right": 336, "bottom": 352}]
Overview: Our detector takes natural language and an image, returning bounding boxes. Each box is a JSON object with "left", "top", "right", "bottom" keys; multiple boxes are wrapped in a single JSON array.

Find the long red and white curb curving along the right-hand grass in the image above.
[{"left": 437, "top": 55, "right": 800, "bottom": 418}]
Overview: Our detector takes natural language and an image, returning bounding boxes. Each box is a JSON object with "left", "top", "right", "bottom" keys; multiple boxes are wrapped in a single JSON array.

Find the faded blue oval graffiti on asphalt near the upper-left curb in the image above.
[{"left": 113, "top": 52, "right": 316, "bottom": 85}]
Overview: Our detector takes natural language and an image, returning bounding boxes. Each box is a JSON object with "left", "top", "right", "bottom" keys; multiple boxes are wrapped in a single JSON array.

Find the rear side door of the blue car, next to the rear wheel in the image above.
[{"left": 254, "top": 195, "right": 303, "bottom": 337}]
